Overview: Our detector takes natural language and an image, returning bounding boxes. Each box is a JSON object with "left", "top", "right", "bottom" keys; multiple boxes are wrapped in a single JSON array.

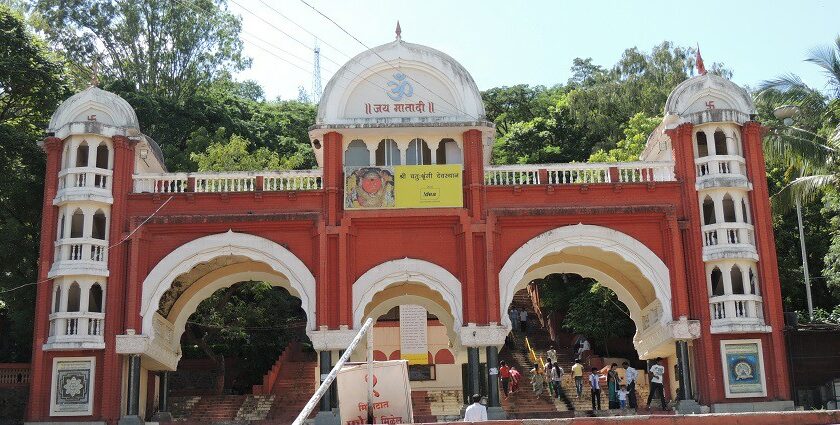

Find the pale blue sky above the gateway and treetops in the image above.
[{"left": 233, "top": 0, "right": 840, "bottom": 99}]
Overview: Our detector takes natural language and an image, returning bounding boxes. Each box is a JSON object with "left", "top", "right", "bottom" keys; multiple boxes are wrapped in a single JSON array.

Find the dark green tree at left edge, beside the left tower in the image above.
[{"left": 0, "top": 5, "right": 67, "bottom": 362}]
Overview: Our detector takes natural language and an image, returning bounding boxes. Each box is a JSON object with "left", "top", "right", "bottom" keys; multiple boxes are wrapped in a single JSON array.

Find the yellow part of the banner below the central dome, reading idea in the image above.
[{"left": 394, "top": 164, "right": 464, "bottom": 208}]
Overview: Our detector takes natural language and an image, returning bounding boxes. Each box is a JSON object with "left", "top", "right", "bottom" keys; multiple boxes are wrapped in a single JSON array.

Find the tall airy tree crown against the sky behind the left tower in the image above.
[{"left": 33, "top": 0, "right": 249, "bottom": 99}]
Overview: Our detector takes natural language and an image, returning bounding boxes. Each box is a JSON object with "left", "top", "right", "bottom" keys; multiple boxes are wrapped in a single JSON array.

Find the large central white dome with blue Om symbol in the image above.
[{"left": 316, "top": 38, "right": 485, "bottom": 125}]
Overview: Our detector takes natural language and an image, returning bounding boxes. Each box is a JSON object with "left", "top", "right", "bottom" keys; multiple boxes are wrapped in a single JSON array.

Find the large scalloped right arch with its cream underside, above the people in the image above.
[{"left": 499, "top": 224, "right": 672, "bottom": 353}]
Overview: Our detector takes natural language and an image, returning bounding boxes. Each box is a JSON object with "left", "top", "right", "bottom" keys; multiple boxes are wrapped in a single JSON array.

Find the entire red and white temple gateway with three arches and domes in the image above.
[{"left": 23, "top": 30, "right": 793, "bottom": 424}]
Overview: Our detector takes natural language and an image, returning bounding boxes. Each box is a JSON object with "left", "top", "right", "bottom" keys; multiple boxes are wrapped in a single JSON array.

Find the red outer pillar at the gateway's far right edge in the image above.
[{"left": 741, "top": 121, "right": 791, "bottom": 400}]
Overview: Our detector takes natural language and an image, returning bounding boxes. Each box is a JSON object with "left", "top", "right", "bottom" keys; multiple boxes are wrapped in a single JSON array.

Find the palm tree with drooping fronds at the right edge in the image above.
[{"left": 757, "top": 36, "right": 840, "bottom": 212}]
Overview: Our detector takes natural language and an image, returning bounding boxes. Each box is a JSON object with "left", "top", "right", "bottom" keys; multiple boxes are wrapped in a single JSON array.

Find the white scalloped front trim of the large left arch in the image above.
[{"left": 140, "top": 231, "right": 316, "bottom": 340}]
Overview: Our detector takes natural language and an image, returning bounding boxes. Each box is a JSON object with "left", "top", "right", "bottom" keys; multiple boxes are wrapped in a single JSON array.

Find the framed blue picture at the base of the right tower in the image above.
[{"left": 720, "top": 339, "right": 767, "bottom": 398}]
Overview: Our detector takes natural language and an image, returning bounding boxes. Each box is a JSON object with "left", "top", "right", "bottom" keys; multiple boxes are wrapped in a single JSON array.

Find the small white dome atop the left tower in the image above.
[{"left": 48, "top": 86, "right": 140, "bottom": 133}]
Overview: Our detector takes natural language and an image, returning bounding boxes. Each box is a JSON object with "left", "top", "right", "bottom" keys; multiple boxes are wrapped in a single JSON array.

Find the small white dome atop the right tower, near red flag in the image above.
[{"left": 664, "top": 74, "right": 755, "bottom": 128}]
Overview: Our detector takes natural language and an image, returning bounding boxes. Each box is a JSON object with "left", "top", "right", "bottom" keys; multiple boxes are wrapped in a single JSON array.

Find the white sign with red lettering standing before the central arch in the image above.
[{"left": 336, "top": 360, "right": 414, "bottom": 425}]
